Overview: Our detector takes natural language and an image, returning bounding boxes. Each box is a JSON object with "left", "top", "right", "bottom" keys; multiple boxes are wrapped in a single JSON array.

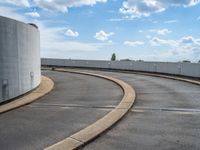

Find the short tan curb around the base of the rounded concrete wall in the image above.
[{"left": 0, "top": 76, "right": 54, "bottom": 114}]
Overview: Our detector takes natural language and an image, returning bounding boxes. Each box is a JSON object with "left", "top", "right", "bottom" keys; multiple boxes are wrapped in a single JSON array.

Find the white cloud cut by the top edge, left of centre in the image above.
[{"left": 33, "top": 0, "right": 107, "bottom": 12}]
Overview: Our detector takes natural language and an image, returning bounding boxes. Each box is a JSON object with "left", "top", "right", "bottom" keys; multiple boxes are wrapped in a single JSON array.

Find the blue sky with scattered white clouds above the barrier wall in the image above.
[{"left": 0, "top": 0, "right": 200, "bottom": 62}]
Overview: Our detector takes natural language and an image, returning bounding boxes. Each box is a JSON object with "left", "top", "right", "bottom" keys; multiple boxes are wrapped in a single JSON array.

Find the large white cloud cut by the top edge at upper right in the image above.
[{"left": 120, "top": 0, "right": 200, "bottom": 18}]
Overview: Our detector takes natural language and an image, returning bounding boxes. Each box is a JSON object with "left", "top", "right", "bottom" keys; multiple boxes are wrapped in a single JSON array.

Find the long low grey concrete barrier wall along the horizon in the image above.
[{"left": 42, "top": 58, "right": 200, "bottom": 78}]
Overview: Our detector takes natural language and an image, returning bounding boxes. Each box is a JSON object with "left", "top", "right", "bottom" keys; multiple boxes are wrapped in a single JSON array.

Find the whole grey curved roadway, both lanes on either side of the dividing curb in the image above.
[{"left": 0, "top": 71, "right": 200, "bottom": 150}]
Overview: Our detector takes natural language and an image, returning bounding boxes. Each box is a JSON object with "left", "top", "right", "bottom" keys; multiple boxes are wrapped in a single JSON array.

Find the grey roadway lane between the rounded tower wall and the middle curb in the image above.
[{"left": 0, "top": 71, "right": 123, "bottom": 150}]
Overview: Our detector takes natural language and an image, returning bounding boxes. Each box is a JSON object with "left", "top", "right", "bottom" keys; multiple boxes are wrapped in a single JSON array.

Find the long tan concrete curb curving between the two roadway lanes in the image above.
[{"left": 45, "top": 69, "right": 136, "bottom": 150}]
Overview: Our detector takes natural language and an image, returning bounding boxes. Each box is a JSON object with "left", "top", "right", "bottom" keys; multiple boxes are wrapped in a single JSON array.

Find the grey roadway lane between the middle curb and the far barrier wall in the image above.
[{"left": 83, "top": 72, "right": 200, "bottom": 150}]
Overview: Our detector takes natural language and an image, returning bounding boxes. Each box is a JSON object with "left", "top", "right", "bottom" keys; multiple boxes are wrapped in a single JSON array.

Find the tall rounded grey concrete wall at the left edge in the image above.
[{"left": 0, "top": 16, "right": 41, "bottom": 102}]
